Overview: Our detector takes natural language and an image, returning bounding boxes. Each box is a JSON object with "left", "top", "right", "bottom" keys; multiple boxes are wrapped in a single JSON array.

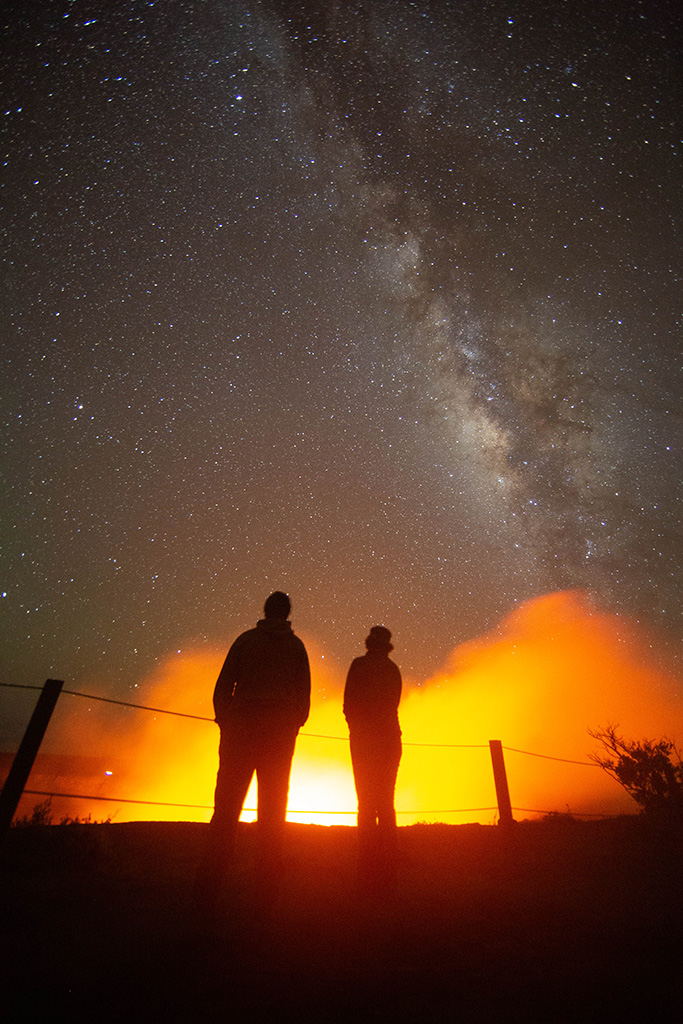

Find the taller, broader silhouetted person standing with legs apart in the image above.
[{"left": 197, "top": 591, "right": 310, "bottom": 905}]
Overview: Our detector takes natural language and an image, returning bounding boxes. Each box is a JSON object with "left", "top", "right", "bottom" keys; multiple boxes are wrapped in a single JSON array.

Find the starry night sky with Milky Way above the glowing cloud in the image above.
[{"left": 0, "top": 0, "right": 683, "bottom": 737}]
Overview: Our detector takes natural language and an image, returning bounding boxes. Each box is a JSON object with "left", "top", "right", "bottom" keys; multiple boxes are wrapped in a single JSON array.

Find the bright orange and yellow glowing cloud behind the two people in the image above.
[{"left": 33, "top": 592, "right": 683, "bottom": 824}]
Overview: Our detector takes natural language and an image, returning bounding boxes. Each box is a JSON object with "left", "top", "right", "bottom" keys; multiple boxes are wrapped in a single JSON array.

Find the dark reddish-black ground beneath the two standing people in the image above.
[{"left": 0, "top": 818, "right": 683, "bottom": 1024}]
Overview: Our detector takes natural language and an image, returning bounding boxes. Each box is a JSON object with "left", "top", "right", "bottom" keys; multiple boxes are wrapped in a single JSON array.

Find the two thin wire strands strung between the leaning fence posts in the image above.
[{"left": 0, "top": 682, "right": 613, "bottom": 818}]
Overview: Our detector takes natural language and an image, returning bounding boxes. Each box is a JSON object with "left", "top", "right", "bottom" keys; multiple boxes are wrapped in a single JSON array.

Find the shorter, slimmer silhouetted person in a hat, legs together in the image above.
[{"left": 344, "top": 626, "right": 401, "bottom": 883}]
